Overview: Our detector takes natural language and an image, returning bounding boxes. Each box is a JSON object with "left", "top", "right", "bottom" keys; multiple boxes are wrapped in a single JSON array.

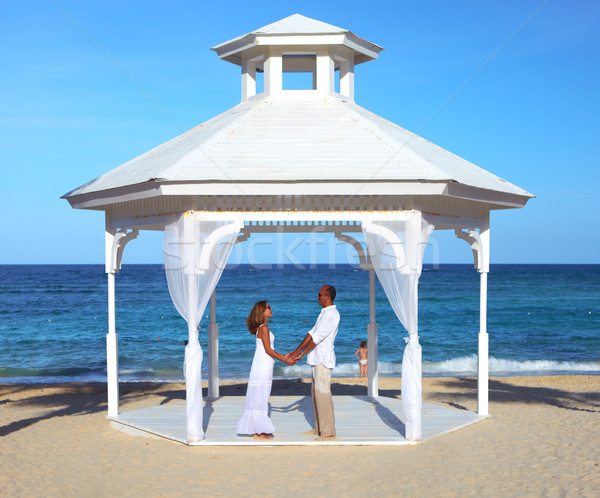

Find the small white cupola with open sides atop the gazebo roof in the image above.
[{"left": 212, "top": 14, "right": 383, "bottom": 101}]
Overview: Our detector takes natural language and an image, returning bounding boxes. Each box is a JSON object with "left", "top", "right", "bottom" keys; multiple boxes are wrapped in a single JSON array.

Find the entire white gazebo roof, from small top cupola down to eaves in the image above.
[{"left": 64, "top": 14, "right": 533, "bottom": 226}]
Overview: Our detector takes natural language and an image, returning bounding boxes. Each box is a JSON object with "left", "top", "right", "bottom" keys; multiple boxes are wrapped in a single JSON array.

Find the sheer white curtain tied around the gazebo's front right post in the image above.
[{"left": 362, "top": 211, "right": 433, "bottom": 441}]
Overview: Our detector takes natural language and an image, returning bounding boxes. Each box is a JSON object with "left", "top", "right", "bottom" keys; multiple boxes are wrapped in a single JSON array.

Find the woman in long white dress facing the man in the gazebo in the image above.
[{"left": 237, "top": 301, "right": 295, "bottom": 439}]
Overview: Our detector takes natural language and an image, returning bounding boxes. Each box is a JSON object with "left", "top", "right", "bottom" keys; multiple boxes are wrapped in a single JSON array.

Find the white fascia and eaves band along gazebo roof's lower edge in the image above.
[{"left": 67, "top": 181, "right": 529, "bottom": 214}]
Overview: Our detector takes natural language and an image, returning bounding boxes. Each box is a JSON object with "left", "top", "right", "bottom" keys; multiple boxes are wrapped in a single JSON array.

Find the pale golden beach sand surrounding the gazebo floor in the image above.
[{"left": 0, "top": 375, "right": 600, "bottom": 497}]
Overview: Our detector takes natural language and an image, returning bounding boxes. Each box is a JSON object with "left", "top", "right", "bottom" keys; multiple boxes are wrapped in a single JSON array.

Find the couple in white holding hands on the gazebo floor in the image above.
[{"left": 237, "top": 285, "right": 340, "bottom": 440}]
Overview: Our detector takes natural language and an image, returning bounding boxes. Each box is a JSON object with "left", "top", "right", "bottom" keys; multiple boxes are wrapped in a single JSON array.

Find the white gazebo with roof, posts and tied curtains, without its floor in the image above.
[{"left": 64, "top": 14, "right": 533, "bottom": 442}]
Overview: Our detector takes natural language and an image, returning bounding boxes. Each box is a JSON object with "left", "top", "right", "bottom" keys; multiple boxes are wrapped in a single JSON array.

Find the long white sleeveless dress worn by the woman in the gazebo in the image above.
[{"left": 237, "top": 325, "right": 275, "bottom": 434}]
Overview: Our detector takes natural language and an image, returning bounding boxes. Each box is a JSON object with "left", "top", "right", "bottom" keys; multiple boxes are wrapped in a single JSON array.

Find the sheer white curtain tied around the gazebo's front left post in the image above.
[{"left": 164, "top": 212, "right": 243, "bottom": 442}]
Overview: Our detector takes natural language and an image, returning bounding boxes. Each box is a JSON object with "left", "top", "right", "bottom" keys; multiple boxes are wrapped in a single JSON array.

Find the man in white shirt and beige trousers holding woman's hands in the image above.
[{"left": 291, "top": 285, "right": 340, "bottom": 440}]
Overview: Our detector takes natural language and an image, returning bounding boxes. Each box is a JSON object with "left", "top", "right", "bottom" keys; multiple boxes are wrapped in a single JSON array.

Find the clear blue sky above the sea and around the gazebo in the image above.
[{"left": 0, "top": 0, "right": 600, "bottom": 264}]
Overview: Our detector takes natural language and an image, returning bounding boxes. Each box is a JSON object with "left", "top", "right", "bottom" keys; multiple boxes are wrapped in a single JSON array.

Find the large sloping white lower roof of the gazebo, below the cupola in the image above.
[{"left": 66, "top": 90, "right": 531, "bottom": 202}]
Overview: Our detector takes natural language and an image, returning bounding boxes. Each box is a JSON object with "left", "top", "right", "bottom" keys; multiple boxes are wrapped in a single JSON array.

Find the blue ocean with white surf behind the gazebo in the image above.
[{"left": 0, "top": 265, "right": 600, "bottom": 383}]
